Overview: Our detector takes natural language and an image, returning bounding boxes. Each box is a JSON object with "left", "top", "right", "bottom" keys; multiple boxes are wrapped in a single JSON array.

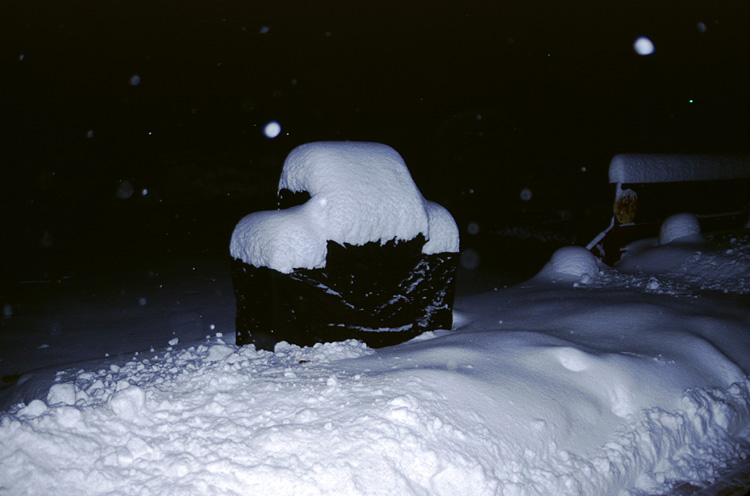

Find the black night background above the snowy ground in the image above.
[{"left": 0, "top": 0, "right": 750, "bottom": 284}]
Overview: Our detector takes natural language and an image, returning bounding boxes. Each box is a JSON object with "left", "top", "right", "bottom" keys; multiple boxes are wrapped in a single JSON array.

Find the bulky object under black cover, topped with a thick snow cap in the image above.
[{"left": 230, "top": 142, "right": 459, "bottom": 349}]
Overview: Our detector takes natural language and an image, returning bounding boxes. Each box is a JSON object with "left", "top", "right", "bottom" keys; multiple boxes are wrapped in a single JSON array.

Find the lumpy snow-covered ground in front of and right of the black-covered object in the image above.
[{"left": 0, "top": 226, "right": 750, "bottom": 496}]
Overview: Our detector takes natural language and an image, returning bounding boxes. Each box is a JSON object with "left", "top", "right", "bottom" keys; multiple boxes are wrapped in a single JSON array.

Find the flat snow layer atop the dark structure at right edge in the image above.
[{"left": 609, "top": 153, "right": 750, "bottom": 184}]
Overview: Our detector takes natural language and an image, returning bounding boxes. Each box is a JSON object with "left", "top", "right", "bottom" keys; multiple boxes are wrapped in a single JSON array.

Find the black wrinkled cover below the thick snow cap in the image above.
[{"left": 232, "top": 236, "right": 458, "bottom": 350}]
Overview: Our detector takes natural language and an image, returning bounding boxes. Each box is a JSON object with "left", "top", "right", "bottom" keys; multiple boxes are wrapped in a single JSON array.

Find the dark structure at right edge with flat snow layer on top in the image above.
[{"left": 586, "top": 154, "right": 750, "bottom": 265}]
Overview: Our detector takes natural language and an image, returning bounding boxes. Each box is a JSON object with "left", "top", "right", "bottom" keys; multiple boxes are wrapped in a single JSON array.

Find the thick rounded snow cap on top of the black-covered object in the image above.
[{"left": 230, "top": 141, "right": 458, "bottom": 273}]
